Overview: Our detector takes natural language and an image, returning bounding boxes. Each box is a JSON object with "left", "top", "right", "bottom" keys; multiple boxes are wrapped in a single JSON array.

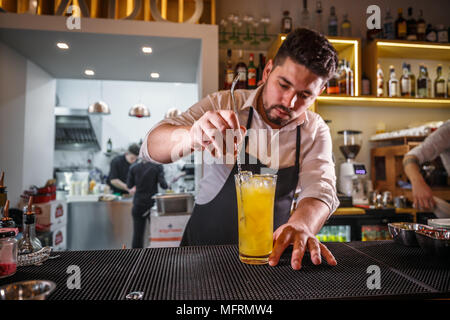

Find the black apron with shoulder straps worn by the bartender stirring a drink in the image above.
[{"left": 180, "top": 107, "right": 301, "bottom": 246}]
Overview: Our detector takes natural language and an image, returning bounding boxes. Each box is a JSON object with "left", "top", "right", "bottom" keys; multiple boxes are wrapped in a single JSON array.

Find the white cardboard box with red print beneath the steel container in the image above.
[{"left": 149, "top": 215, "right": 191, "bottom": 248}]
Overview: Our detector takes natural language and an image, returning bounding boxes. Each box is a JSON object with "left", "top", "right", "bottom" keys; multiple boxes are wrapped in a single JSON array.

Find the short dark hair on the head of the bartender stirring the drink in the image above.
[{"left": 273, "top": 28, "right": 338, "bottom": 80}]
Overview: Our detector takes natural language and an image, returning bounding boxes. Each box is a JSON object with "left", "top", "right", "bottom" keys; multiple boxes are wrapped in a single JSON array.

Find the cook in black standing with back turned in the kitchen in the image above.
[{"left": 127, "top": 160, "right": 167, "bottom": 248}]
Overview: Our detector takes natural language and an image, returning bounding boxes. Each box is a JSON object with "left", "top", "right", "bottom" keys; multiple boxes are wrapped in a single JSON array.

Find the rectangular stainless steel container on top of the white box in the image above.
[{"left": 153, "top": 193, "right": 194, "bottom": 214}]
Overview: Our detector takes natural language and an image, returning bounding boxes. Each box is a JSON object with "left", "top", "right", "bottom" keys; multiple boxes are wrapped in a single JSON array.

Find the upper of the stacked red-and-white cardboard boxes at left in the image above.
[{"left": 34, "top": 200, "right": 67, "bottom": 231}]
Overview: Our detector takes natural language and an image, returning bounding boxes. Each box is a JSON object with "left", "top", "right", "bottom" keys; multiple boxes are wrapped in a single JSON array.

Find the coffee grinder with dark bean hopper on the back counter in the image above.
[{"left": 338, "top": 130, "right": 369, "bottom": 205}]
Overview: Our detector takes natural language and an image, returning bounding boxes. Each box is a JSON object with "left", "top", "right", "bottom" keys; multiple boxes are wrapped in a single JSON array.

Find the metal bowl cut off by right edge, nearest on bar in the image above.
[{"left": 416, "top": 228, "right": 450, "bottom": 259}]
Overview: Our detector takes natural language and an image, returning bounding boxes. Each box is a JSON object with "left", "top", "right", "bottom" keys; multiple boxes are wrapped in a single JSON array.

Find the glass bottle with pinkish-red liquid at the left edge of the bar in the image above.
[{"left": 0, "top": 231, "right": 17, "bottom": 279}]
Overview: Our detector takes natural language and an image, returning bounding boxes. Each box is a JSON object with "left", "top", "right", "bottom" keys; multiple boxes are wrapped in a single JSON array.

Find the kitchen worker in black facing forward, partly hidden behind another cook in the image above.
[{"left": 108, "top": 143, "right": 139, "bottom": 195}]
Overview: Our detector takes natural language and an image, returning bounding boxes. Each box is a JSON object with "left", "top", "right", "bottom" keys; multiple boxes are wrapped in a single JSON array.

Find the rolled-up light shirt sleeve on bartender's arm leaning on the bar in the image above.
[{"left": 297, "top": 120, "right": 339, "bottom": 218}]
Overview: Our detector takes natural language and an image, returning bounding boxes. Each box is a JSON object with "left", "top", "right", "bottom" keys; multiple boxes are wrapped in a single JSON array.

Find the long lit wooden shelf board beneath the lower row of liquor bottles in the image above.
[{"left": 317, "top": 95, "right": 450, "bottom": 108}]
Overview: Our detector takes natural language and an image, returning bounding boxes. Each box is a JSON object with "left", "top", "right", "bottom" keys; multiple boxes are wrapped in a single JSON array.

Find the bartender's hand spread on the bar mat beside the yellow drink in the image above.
[{"left": 269, "top": 223, "right": 337, "bottom": 270}]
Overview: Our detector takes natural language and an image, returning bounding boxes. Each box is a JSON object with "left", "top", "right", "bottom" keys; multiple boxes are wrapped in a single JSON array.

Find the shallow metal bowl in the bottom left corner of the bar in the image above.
[{"left": 0, "top": 280, "right": 56, "bottom": 300}]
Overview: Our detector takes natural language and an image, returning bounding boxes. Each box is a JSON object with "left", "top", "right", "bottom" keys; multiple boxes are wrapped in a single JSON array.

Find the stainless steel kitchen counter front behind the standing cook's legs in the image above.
[{"left": 67, "top": 199, "right": 149, "bottom": 250}]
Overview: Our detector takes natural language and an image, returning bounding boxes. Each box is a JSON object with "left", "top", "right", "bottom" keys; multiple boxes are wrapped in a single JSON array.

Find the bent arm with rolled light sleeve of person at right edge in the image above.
[{"left": 403, "top": 120, "right": 450, "bottom": 210}]
